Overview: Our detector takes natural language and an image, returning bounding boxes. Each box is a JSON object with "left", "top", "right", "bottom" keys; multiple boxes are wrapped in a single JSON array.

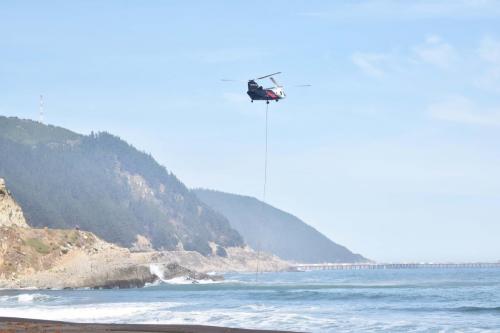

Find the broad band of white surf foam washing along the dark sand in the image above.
[{"left": 0, "top": 301, "right": 492, "bottom": 332}]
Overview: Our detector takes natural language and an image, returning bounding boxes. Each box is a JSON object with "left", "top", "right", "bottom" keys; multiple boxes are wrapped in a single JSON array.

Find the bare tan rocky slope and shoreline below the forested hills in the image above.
[{"left": 0, "top": 178, "right": 289, "bottom": 289}]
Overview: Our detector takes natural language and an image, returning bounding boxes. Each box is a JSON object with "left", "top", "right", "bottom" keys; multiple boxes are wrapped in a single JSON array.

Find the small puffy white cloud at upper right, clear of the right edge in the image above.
[{"left": 413, "top": 35, "right": 458, "bottom": 69}]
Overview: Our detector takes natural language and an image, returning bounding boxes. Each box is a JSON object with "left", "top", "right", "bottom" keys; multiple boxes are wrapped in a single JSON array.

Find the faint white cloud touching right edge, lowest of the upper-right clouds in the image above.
[{"left": 428, "top": 96, "right": 500, "bottom": 126}]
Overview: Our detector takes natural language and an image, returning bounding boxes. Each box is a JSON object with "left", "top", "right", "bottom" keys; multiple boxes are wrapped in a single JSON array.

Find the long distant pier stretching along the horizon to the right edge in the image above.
[{"left": 292, "top": 262, "right": 500, "bottom": 271}]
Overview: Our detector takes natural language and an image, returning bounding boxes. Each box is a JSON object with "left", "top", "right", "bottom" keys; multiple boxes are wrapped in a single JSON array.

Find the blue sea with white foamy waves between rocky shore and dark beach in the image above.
[{"left": 0, "top": 268, "right": 500, "bottom": 332}]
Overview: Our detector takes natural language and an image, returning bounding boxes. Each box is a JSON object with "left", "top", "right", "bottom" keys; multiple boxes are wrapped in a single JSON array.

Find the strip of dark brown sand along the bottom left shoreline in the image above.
[{"left": 0, "top": 317, "right": 300, "bottom": 333}]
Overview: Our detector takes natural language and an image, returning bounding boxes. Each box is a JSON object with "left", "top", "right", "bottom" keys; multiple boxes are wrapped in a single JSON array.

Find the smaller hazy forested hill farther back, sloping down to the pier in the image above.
[{"left": 194, "top": 189, "right": 368, "bottom": 263}]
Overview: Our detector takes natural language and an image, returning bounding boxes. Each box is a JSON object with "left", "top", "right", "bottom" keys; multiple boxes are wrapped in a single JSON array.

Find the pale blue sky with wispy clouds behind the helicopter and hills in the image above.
[{"left": 0, "top": 0, "right": 500, "bottom": 262}]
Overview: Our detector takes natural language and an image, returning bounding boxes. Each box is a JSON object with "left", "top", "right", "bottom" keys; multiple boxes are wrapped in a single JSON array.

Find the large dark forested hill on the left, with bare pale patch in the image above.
[{"left": 0, "top": 116, "right": 243, "bottom": 255}]
